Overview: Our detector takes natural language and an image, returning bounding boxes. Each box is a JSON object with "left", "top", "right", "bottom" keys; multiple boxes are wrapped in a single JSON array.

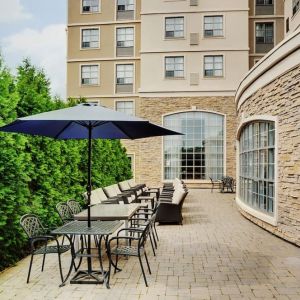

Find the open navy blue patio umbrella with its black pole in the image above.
[{"left": 0, "top": 104, "right": 181, "bottom": 284}]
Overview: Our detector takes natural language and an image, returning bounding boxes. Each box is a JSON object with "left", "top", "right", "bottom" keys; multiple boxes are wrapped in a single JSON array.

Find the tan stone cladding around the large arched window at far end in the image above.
[{"left": 123, "top": 96, "right": 236, "bottom": 187}]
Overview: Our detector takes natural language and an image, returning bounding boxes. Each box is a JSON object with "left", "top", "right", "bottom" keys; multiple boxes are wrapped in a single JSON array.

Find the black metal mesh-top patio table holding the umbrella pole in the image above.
[{"left": 51, "top": 221, "right": 122, "bottom": 288}]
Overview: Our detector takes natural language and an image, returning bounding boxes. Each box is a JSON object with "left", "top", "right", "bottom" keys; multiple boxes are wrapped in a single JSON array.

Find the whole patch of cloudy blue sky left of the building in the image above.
[{"left": 0, "top": 0, "right": 67, "bottom": 98}]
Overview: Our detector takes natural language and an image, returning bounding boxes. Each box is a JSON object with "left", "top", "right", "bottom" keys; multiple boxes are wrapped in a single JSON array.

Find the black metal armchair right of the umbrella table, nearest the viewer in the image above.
[{"left": 107, "top": 223, "right": 151, "bottom": 287}]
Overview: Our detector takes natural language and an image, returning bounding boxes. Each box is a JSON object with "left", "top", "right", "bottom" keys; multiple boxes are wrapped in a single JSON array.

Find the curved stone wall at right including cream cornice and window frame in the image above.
[{"left": 236, "top": 30, "right": 300, "bottom": 245}]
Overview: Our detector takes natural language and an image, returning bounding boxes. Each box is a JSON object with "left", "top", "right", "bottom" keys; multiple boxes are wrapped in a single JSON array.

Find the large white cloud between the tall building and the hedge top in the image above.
[{"left": 1, "top": 24, "right": 66, "bottom": 98}]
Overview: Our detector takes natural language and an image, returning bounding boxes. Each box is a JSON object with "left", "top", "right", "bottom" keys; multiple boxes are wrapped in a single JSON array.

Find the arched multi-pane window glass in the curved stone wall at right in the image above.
[{"left": 239, "top": 122, "right": 275, "bottom": 215}]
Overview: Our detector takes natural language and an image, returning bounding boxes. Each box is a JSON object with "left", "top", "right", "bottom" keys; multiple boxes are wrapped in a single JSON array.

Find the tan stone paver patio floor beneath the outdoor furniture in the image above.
[{"left": 0, "top": 190, "right": 300, "bottom": 300}]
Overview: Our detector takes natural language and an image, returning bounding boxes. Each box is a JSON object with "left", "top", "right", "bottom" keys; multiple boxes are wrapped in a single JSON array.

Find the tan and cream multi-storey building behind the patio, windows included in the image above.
[{"left": 67, "top": 0, "right": 283, "bottom": 186}]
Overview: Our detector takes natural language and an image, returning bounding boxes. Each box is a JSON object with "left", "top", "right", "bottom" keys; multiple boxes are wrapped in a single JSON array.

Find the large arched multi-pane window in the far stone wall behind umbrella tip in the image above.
[{"left": 164, "top": 111, "right": 224, "bottom": 180}]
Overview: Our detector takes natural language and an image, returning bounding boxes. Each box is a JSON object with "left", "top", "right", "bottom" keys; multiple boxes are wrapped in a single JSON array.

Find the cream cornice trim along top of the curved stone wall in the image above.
[{"left": 235, "top": 29, "right": 300, "bottom": 110}]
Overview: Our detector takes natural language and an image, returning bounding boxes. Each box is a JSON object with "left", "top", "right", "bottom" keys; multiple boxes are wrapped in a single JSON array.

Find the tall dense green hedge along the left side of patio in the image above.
[{"left": 0, "top": 58, "right": 132, "bottom": 270}]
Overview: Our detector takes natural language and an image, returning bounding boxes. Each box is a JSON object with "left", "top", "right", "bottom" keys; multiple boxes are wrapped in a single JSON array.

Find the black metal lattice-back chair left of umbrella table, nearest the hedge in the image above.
[{"left": 20, "top": 214, "right": 72, "bottom": 283}]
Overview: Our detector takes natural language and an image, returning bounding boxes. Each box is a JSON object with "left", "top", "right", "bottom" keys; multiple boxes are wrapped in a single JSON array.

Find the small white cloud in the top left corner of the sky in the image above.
[{"left": 0, "top": 0, "right": 32, "bottom": 23}]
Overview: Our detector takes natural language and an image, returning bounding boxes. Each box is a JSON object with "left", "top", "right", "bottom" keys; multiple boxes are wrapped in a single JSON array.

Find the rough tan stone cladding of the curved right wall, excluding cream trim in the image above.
[{"left": 238, "top": 65, "right": 300, "bottom": 246}]
